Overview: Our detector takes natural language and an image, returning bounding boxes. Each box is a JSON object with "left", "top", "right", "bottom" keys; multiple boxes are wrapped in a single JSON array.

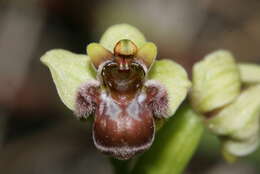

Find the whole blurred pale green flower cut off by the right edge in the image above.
[{"left": 191, "top": 51, "right": 260, "bottom": 160}]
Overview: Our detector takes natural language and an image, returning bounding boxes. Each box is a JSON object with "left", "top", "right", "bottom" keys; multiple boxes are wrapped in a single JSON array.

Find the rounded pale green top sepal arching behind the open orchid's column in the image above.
[{"left": 100, "top": 24, "right": 146, "bottom": 53}]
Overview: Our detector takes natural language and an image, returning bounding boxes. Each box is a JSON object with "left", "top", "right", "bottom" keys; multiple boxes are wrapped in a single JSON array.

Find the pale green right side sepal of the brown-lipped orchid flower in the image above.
[{"left": 148, "top": 59, "right": 191, "bottom": 116}]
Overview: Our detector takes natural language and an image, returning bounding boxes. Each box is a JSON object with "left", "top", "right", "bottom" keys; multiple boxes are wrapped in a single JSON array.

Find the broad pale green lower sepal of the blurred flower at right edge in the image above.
[{"left": 207, "top": 85, "right": 260, "bottom": 140}]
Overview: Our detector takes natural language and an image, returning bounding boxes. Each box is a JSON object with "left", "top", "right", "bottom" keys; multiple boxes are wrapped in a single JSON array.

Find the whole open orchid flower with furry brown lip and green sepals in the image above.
[{"left": 41, "top": 24, "right": 191, "bottom": 160}]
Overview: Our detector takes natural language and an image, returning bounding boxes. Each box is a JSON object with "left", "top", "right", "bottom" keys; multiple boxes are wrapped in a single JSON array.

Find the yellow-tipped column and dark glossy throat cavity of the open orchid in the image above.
[{"left": 101, "top": 39, "right": 145, "bottom": 102}]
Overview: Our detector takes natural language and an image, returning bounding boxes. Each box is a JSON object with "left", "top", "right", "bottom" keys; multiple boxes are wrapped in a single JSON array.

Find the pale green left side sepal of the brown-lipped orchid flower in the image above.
[{"left": 41, "top": 49, "right": 96, "bottom": 110}]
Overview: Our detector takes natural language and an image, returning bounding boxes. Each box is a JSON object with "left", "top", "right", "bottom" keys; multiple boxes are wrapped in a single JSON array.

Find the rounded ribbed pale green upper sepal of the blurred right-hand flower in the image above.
[{"left": 191, "top": 50, "right": 241, "bottom": 113}]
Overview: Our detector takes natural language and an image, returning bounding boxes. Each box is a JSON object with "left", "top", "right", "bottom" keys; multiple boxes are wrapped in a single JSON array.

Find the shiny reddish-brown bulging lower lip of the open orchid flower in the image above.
[{"left": 93, "top": 94, "right": 155, "bottom": 159}]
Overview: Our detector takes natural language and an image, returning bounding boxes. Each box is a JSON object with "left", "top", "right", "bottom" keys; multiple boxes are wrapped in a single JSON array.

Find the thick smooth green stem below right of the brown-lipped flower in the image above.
[{"left": 132, "top": 105, "right": 203, "bottom": 174}]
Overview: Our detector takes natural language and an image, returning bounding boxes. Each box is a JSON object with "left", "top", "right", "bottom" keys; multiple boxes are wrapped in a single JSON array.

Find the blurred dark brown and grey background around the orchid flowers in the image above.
[{"left": 0, "top": 0, "right": 260, "bottom": 174}]
